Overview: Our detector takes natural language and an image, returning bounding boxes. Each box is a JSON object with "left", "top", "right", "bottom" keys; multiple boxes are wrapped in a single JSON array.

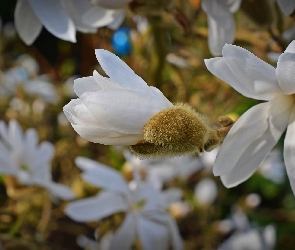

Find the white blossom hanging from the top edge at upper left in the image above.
[{"left": 14, "top": 0, "right": 124, "bottom": 45}]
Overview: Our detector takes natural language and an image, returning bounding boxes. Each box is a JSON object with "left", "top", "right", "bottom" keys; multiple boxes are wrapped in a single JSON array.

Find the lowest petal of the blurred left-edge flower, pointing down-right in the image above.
[{"left": 35, "top": 180, "right": 75, "bottom": 200}]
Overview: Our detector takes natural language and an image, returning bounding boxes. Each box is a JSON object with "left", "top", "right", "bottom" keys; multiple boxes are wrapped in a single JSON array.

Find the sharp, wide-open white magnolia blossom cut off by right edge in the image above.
[{"left": 205, "top": 41, "right": 295, "bottom": 193}]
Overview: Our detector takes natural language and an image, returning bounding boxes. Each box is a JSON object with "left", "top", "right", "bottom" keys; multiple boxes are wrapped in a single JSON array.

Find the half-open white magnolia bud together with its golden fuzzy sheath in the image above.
[{"left": 64, "top": 50, "right": 216, "bottom": 157}]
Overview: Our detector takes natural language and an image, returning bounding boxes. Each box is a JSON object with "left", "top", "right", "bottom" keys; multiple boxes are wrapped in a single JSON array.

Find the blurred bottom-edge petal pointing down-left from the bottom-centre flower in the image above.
[{"left": 110, "top": 213, "right": 137, "bottom": 250}]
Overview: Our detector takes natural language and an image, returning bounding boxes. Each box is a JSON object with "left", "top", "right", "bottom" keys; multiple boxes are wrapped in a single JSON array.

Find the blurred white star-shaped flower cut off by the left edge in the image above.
[{"left": 0, "top": 120, "right": 74, "bottom": 200}]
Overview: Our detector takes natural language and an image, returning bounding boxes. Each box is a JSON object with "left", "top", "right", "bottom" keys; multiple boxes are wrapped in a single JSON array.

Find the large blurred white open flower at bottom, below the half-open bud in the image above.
[{"left": 65, "top": 157, "right": 182, "bottom": 250}]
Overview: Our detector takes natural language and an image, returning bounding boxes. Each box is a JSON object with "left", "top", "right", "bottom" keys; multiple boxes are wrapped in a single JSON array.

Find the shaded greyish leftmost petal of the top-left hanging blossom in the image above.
[{"left": 14, "top": 0, "right": 42, "bottom": 45}]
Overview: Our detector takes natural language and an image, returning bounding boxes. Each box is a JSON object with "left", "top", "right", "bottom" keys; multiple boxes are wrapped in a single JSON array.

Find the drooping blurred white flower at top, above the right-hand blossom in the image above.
[{"left": 202, "top": 0, "right": 242, "bottom": 56}]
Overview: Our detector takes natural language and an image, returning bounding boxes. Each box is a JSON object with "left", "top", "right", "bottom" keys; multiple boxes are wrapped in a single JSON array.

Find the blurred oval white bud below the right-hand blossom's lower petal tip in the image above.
[{"left": 195, "top": 178, "right": 218, "bottom": 205}]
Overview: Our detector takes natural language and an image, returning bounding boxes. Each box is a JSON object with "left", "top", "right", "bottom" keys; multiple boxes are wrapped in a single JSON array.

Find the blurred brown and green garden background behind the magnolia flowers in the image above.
[{"left": 0, "top": 0, "right": 295, "bottom": 250}]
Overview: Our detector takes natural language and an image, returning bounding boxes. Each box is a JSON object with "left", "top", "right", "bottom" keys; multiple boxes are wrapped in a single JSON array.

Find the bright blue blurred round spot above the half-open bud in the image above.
[{"left": 111, "top": 27, "right": 131, "bottom": 56}]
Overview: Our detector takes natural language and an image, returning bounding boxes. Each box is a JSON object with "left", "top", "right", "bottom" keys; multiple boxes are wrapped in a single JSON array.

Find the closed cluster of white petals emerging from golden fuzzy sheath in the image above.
[{"left": 64, "top": 49, "right": 173, "bottom": 145}]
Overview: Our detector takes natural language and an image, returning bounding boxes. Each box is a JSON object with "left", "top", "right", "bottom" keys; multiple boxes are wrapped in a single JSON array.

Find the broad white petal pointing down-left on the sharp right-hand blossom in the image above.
[{"left": 213, "top": 95, "right": 293, "bottom": 176}]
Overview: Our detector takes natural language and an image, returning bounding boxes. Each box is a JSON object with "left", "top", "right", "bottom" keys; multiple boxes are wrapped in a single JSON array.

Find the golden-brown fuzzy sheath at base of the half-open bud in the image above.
[{"left": 130, "top": 103, "right": 211, "bottom": 157}]
